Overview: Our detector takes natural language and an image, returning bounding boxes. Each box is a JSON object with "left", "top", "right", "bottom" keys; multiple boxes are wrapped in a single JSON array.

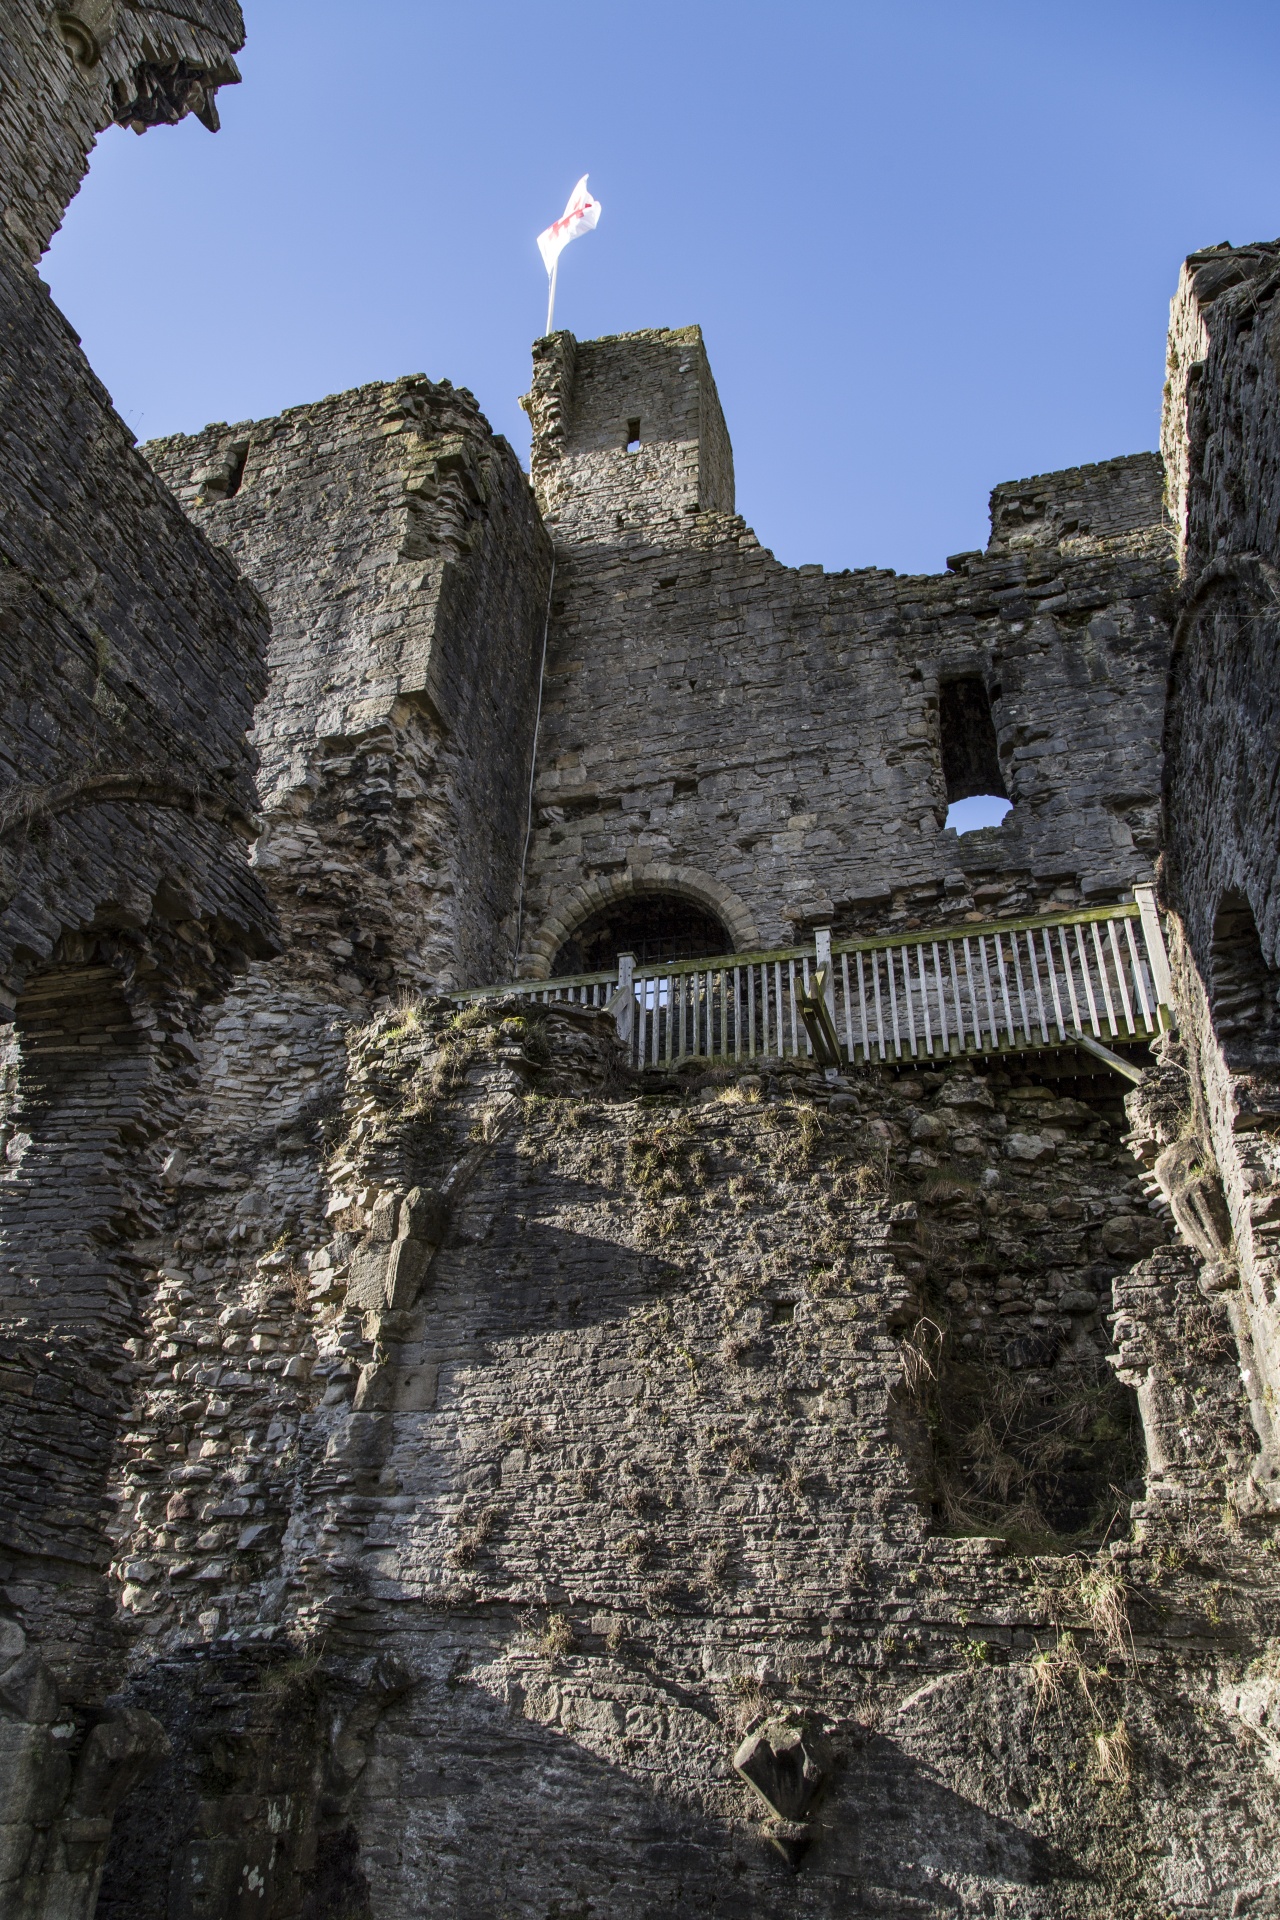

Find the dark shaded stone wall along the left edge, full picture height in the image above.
[{"left": 0, "top": 0, "right": 274, "bottom": 1920}]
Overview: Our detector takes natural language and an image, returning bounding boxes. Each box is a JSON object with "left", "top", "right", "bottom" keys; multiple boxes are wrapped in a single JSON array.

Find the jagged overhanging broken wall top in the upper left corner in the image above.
[{"left": 0, "top": 0, "right": 244, "bottom": 263}]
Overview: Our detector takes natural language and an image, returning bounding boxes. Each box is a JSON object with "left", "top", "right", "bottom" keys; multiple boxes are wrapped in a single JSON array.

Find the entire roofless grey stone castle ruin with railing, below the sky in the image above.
[{"left": 0, "top": 0, "right": 1280, "bottom": 1920}]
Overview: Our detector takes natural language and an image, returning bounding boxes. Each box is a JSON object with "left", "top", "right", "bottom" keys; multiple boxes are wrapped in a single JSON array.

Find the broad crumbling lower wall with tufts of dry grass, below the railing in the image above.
[{"left": 104, "top": 1002, "right": 1276, "bottom": 1920}]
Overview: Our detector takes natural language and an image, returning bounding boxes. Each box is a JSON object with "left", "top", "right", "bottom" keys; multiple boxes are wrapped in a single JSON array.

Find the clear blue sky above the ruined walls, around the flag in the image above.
[{"left": 44, "top": 0, "right": 1280, "bottom": 572}]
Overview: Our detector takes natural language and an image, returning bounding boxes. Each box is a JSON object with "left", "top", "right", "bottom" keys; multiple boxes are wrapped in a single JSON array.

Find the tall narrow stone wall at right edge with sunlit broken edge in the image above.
[{"left": 1161, "top": 244, "right": 1280, "bottom": 1503}]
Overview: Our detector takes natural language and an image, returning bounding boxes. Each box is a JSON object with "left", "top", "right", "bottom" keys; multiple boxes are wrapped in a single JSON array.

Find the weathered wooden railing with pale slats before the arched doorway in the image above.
[{"left": 453, "top": 887, "right": 1171, "bottom": 1068}]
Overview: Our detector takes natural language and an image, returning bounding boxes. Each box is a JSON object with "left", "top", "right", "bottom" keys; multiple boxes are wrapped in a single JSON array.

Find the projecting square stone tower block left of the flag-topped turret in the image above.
[{"left": 146, "top": 378, "right": 551, "bottom": 993}]
